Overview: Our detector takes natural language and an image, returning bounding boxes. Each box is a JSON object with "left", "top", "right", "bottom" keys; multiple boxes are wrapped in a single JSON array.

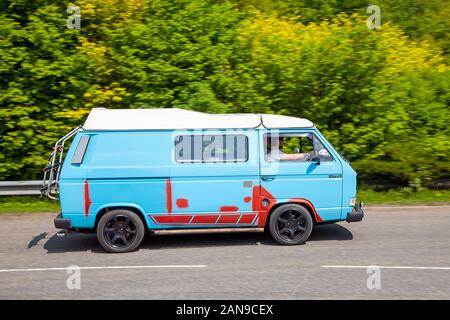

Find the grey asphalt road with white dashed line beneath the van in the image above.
[{"left": 0, "top": 206, "right": 450, "bottom": 299}]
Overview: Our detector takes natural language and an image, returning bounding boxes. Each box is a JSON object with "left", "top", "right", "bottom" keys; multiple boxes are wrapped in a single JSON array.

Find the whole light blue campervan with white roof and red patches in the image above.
[{"left": 42, "top": 108, "right": 364, "bottom": 252}]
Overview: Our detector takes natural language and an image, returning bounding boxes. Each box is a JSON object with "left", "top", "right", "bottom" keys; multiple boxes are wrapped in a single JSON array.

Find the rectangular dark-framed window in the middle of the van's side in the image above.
[{"left": 175, "top": 134, "right": 248, "bottom": 163}]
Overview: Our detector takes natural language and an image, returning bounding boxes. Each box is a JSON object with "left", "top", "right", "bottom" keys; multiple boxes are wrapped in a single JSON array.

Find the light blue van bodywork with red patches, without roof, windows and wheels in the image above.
[{"left": 59, "top": 128, "right": 356, "bottom": 229}]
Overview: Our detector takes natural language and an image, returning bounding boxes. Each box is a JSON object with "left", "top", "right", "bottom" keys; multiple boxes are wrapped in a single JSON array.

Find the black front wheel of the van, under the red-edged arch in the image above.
[{"left": 269, "top": 204, "right": 313, "bottom": 245}]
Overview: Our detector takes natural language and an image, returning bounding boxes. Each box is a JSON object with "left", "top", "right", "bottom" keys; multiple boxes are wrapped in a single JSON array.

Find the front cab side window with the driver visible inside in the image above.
[{"left": 264, "top": 133, "right": 333, "bottom": 162}]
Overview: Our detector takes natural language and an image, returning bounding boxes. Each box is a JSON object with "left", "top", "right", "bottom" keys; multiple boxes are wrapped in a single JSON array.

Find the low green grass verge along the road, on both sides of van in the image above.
[{"left": 0, "top": 188, "right": 450, "bottom": 214}]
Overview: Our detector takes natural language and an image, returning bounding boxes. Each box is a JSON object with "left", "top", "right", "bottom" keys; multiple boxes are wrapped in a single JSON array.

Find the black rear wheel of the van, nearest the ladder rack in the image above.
[{"left": 97, "top": 209, "right": 145, "bottom": 253}]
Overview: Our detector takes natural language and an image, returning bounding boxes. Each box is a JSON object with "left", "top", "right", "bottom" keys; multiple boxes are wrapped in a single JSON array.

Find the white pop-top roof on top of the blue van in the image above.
[{"left": 83, "top": 108, "right": 314, "bottom": 130}]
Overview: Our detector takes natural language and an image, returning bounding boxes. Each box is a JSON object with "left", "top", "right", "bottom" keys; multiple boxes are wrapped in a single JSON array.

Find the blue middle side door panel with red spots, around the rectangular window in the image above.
[{"left": 170, "top": 130, "right": 259, "bottom": 221}]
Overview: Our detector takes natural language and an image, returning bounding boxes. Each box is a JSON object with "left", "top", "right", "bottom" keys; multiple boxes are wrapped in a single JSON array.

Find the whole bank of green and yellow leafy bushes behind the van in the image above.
[{"left": 0, "top": 0, "right": 450, "bottom": 189}]
